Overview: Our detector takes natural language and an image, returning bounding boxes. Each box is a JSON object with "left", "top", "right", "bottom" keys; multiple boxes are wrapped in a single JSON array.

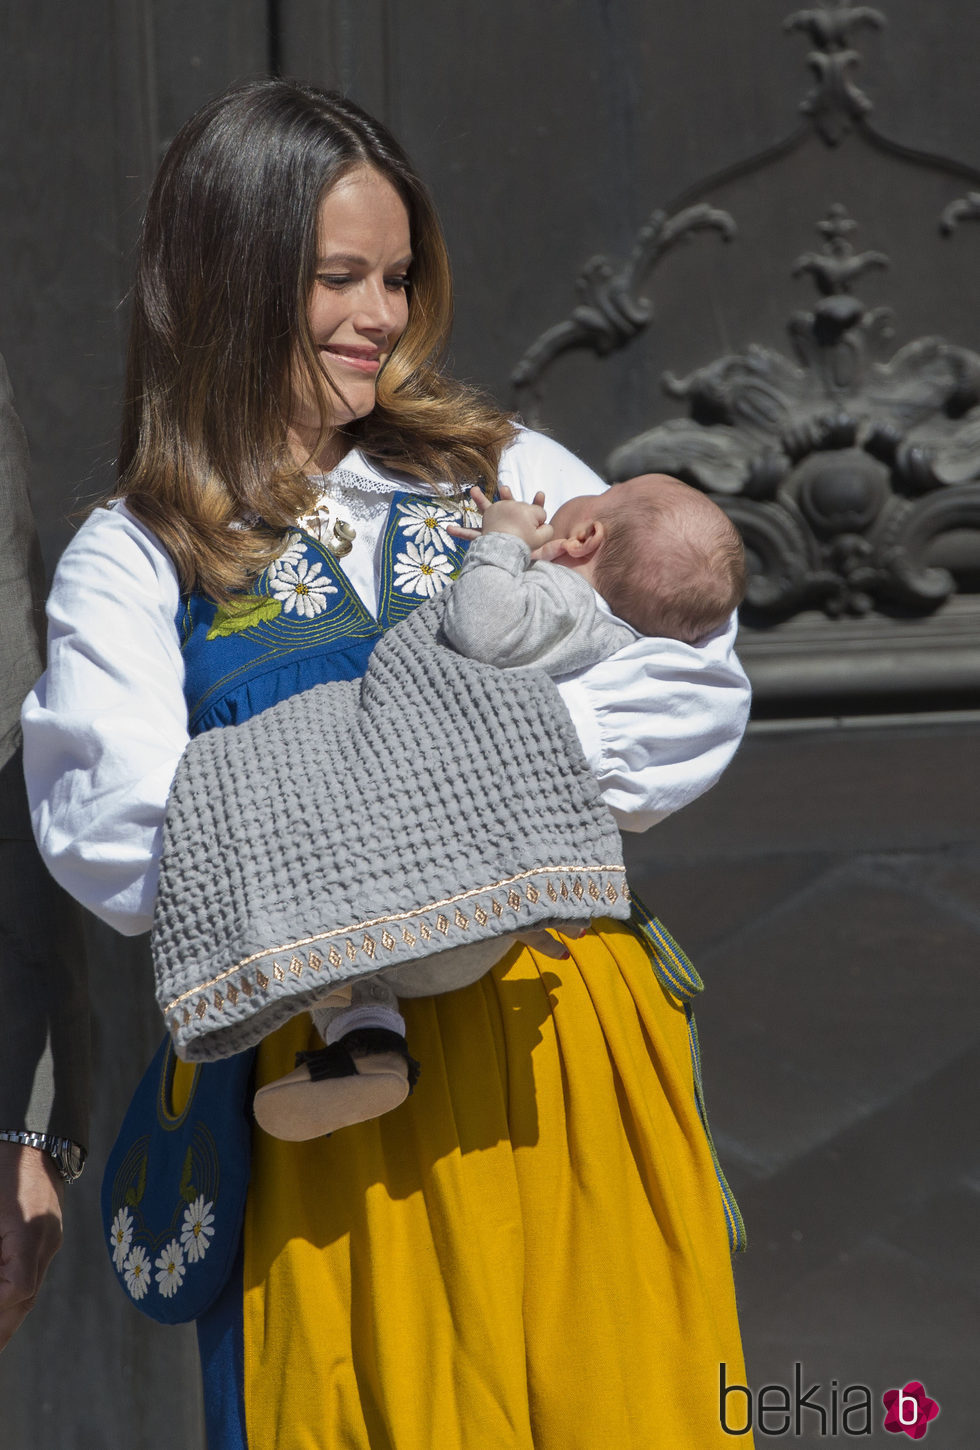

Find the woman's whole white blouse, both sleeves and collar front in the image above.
[{"left": 22, "top": 429, "right": 749, "bottom": 935}]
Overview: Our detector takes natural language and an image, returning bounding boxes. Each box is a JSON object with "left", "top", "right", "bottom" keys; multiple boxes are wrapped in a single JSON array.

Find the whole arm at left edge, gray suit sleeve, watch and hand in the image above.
[{"left": 0, "top": 350, "right": 88, "bottom": 1349}]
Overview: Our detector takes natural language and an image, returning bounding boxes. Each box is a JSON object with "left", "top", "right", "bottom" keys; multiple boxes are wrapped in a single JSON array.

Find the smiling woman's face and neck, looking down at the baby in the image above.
[{"left": 290, "top": 165, "right": 412, "bottom": 465}]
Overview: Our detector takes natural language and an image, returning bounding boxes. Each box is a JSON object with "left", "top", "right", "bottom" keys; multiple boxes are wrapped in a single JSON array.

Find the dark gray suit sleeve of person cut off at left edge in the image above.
[{"left": 0, "top": 358, "right": 88, "bottom": 1147}]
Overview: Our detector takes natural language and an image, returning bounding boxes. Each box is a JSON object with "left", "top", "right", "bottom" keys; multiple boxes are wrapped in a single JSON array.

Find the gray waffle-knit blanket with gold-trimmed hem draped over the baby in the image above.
[{"left": 152, "top": 597, "right": 629, "bottom": 1060}]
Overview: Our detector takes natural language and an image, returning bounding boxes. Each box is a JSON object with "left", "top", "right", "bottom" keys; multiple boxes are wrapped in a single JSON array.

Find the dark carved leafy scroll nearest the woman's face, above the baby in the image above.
[{"left": 510, "top": 204, "right": 735, "bottom": 422}]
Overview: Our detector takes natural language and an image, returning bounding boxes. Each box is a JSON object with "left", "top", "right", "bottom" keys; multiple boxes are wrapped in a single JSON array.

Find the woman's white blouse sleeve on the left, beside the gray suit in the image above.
[{"left": 22, "top": 505, "right": 188, "bottom": 935}]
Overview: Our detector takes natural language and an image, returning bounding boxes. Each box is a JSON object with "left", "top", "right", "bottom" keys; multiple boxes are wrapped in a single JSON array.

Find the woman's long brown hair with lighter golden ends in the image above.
[{"left": 115, "top": 81, "right": 513, "bottom": 599}]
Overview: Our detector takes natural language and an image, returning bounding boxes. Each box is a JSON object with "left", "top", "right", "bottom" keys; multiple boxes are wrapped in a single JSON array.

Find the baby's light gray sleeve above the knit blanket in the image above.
[{"left": 442, "top": 534, "right": 632, "bottom": 676}]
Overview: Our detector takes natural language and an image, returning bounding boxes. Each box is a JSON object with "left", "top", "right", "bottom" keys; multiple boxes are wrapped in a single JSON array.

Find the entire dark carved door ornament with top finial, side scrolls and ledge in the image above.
[{"left": 512, "top": 0, "right": 980, "bottom": 701}]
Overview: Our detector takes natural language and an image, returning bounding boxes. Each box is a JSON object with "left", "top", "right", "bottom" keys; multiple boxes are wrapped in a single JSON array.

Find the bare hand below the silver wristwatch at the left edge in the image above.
[{"left": 0, "top": 1141, "right": 65, "bottom": 1350}]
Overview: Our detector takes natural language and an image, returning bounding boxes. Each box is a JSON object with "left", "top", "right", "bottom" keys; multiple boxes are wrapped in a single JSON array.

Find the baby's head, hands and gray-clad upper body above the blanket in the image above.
[{"left": 444, "top": 474, "right": 745, "bottom": 676}]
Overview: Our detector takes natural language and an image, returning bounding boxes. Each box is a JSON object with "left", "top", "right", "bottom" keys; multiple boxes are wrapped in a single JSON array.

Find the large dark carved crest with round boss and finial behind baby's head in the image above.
[{"left": 607, "top": 204, "right": 980, "bottom": 621}]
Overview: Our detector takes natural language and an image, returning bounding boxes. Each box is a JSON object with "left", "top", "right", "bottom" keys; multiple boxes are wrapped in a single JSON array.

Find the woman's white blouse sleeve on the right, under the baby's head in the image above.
[{"left": 500, "top": 431, "right": 749, "bottom": 831}]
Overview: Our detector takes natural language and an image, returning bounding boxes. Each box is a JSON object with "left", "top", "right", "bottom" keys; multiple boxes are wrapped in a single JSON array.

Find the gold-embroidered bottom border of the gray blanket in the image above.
[{"left": 164, "top": 863, "right": 631, "bottom": 1060}]
